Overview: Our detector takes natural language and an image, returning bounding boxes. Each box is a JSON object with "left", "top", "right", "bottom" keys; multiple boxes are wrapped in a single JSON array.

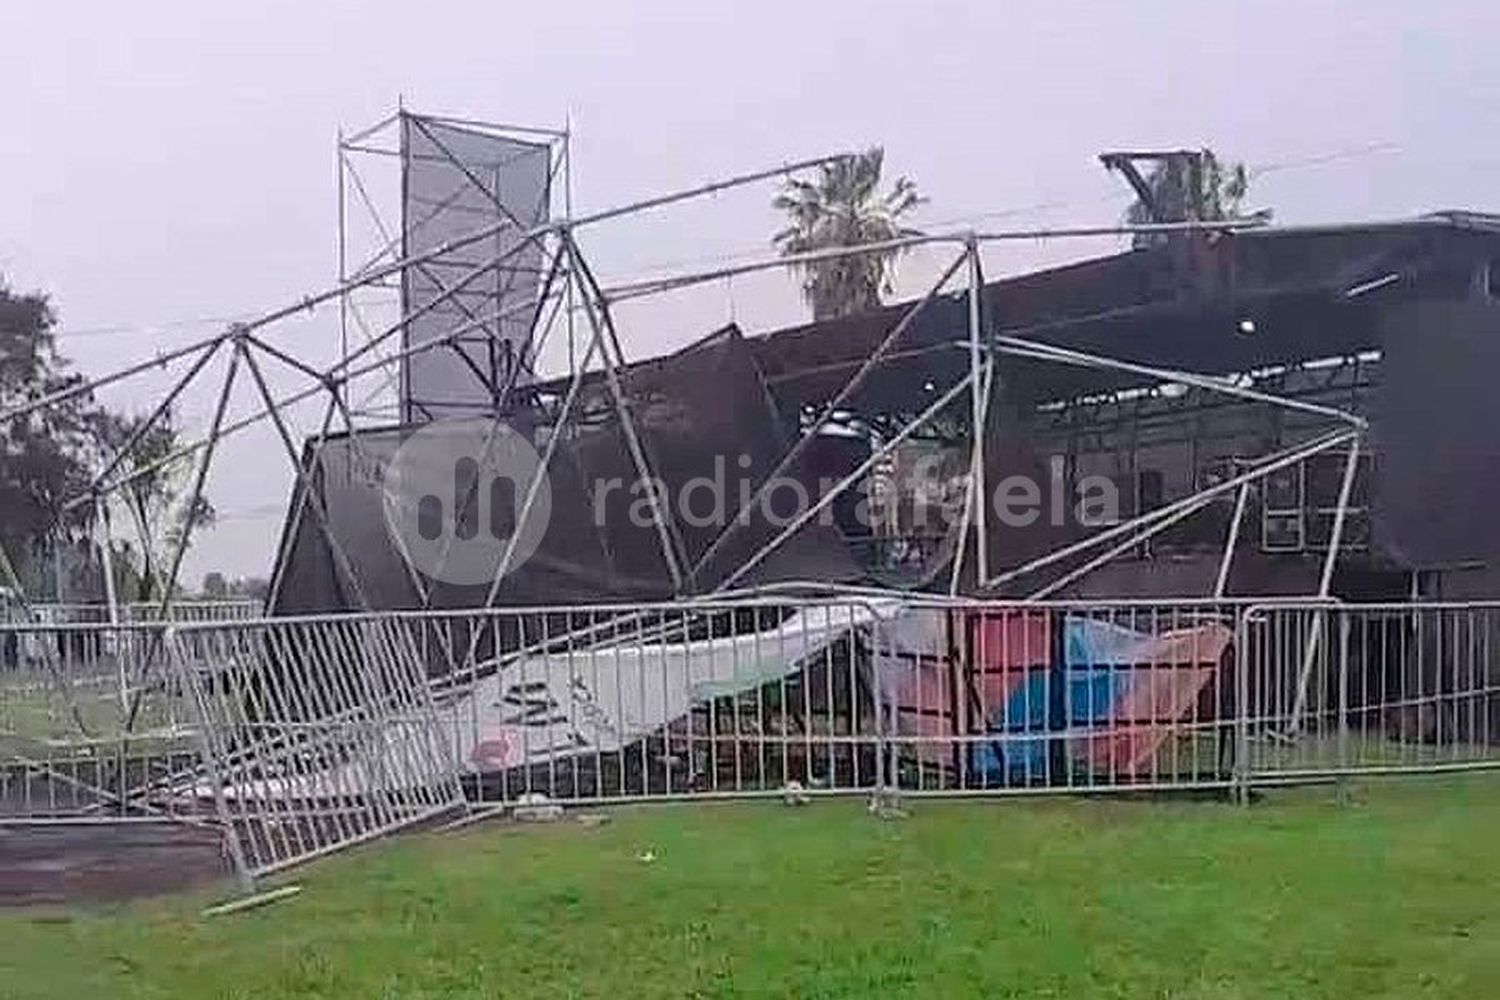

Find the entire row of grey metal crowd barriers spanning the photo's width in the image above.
[{"left": 0, "top": 595, "right": 1500, "bottom": 877}]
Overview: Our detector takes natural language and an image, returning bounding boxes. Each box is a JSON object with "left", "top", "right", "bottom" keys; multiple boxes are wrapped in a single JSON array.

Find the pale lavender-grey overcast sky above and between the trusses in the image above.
[{"left": 0, "top": 0, "right": 1500, "bottom": 585}]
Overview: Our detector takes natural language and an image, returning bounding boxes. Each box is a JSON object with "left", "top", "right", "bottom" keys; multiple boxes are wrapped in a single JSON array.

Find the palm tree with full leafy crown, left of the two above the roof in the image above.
[{"left": 771, "top": 147, "right": 926, "bottom": 319}]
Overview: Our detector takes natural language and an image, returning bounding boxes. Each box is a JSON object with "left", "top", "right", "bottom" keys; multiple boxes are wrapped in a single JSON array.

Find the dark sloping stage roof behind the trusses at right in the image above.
[{"left": 749, "top": 213, "right": 1500, "bottom": 409}]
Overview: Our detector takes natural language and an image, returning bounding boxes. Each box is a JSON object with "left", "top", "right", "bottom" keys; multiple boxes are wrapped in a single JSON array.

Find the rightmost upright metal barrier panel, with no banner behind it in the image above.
[{"left": 1238, "top": 603, "right": 1500, "bottom": 786}]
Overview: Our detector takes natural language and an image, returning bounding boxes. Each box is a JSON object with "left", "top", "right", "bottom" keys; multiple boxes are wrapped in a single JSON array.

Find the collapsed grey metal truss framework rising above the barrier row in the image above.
[{"left": 0, "top": 112, "right": 1367, "bottom": 632}]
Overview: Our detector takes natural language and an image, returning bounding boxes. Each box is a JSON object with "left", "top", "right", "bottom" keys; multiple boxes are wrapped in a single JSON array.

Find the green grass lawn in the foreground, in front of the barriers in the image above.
[{"left": 0, "top": 777, "right": 1500, "bottom": 999}]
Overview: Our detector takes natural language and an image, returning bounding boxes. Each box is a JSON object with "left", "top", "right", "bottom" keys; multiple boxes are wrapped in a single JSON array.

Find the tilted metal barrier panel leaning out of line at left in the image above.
[{"left": 168, "top": 615, "right": 465, "bottom": 880}]
